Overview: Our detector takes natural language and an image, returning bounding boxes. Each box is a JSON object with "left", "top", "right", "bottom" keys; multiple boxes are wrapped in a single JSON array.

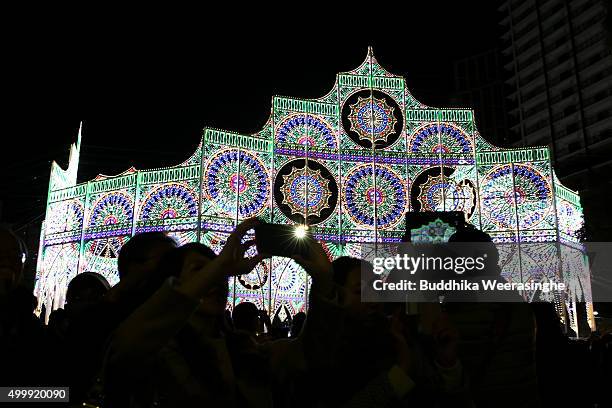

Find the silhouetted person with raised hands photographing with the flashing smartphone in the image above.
[{"left": 107, "top": 219, "right": 329, "bottom": 407}]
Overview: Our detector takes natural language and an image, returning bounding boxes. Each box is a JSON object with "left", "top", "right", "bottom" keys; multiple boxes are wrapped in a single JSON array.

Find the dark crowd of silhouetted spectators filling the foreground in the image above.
[{"left": 0, "top": 219, "right": 612, "bottom": 407}]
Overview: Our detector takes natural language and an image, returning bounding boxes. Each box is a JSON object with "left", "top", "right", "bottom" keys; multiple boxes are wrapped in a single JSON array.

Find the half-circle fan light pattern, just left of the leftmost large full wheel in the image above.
[{"left": 141, "top": 183, "right": 198, "bottom": 220}]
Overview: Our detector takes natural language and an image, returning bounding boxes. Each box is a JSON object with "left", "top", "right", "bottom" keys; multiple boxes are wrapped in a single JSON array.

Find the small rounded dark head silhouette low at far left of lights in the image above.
[{"left": 66, "top": 272, "right": 110, "bottom": 312}]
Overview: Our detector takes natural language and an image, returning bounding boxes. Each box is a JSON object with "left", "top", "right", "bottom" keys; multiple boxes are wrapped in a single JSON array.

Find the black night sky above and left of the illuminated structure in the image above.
[{"left": 0, "top": 5, "right": 501, "bottom": 227}]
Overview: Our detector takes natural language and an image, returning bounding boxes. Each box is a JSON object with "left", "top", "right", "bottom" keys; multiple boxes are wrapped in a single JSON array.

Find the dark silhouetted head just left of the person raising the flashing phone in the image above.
[{"left": 117, "top": 232, "right": 177, "bottom": 280}]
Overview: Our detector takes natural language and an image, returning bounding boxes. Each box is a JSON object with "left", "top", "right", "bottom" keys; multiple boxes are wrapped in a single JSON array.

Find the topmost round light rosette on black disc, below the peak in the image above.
[{"left": 342, "top": 90, "right": 404, "bottom": 149}]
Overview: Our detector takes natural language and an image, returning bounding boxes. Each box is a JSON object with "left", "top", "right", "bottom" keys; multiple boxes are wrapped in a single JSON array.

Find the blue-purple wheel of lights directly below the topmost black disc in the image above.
[{"left": 344, "top": 165, "right": 406, "bottom": 228}]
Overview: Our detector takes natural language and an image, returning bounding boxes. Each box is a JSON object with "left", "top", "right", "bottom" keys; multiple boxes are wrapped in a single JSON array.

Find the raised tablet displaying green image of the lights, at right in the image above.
[{"left": 406, "top": 211, "right": 466, "bottom": 244}]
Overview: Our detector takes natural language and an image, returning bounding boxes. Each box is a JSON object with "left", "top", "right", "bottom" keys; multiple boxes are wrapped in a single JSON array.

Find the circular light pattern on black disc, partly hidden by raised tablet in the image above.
[{"left": 417, "top": 175, "right": 476, "bottom": 217}]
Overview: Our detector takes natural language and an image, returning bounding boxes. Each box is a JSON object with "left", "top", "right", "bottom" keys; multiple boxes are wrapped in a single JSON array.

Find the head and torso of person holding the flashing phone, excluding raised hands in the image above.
[{"left": 107, "top": 226, "right": 258, "bottom": 406}]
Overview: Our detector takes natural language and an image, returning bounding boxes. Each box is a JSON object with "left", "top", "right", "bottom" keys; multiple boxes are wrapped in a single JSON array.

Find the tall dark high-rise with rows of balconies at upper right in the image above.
[{"left": 499, "top": 0, "right": 612, "bottom": 241}]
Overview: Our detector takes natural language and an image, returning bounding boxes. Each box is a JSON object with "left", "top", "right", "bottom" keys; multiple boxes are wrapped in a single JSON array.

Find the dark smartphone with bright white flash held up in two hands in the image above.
[{"left": 255, "top": 224, "right": 314, "bottom": 258}]
